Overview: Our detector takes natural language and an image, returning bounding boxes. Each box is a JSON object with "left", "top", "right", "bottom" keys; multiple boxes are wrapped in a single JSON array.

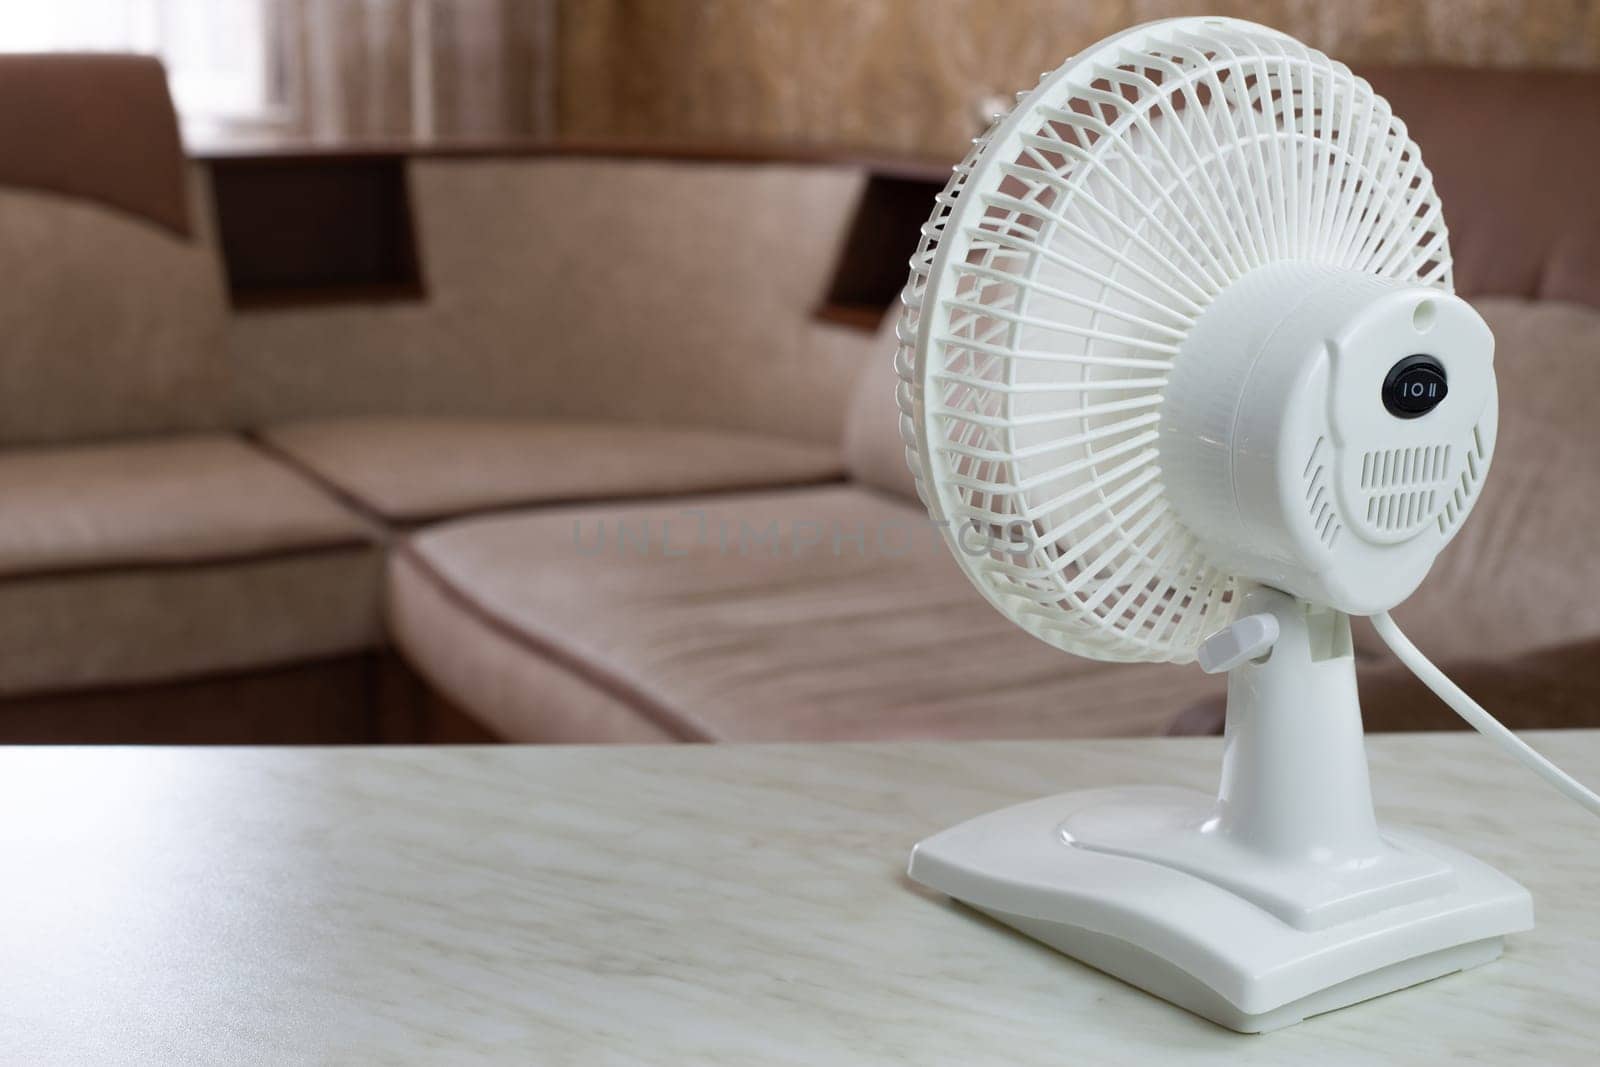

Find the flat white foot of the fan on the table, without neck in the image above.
[{"left": 910, "top": 787, "right": 1533, "bottom": 1033}]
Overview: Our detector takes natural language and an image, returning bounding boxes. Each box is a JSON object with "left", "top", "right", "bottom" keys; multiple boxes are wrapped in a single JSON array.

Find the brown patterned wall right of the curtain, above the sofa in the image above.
[{"left": 557, "top": 0, "right": 1600, "bottom": 157}]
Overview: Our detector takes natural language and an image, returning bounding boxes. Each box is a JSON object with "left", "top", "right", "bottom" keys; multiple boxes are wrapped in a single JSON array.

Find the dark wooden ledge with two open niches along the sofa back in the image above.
[{"left": 200, "top": 141, "right": 950, "bottom": 313}]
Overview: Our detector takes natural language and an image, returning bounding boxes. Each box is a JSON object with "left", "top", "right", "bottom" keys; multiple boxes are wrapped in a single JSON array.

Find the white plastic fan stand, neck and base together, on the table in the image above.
[{"left": 910, "top": 589, "right": 1533, "bottom": 1033}]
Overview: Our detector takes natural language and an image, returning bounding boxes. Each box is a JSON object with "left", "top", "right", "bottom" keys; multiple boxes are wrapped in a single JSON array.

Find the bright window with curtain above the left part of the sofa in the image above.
[{"left": 0, "top": 0, "right": 558, "bottom": 147}]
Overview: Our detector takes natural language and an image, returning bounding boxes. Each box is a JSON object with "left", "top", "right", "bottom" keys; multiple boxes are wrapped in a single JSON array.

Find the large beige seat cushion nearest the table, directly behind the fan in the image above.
[{"left": 387, "top": 486, "right": 1221, "bottom": 741}]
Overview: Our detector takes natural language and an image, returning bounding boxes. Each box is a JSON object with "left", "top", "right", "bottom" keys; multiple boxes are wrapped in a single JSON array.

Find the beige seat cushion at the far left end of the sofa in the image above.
[{"left": 0, "top": 435, "right": 382, "bottom": 694}]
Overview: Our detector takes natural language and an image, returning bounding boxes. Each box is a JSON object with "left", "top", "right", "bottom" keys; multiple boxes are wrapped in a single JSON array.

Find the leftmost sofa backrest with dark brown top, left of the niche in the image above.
[{"left": 0, "top": 56, "right": 227, "bottom": 445}]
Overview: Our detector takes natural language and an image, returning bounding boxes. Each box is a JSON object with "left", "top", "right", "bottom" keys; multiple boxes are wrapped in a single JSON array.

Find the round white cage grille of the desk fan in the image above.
[{"left": 896, "top": 19, "right": 1451, "bottom": 662}]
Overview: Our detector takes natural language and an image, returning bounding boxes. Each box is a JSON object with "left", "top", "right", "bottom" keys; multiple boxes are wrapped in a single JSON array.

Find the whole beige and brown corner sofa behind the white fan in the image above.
[{"left": 0, "top": 59, "right": 1600, "bottom": 742}]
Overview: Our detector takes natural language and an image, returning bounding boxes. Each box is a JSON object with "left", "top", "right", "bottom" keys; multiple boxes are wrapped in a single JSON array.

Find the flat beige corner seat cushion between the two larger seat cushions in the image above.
[{"left": 259, "top": 416, "right": 842, "bottom": 522}]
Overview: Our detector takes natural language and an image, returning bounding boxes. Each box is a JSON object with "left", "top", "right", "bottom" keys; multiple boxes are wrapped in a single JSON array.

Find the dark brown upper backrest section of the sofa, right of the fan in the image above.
[{"left": 1357, "top": 67, "right": 1600, "bottom": 307}]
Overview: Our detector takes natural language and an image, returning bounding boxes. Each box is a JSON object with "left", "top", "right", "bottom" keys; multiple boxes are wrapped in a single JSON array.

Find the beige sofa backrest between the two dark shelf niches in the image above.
[{"left": 230, "top": 155, "right": 872, "bottom": 445}]
